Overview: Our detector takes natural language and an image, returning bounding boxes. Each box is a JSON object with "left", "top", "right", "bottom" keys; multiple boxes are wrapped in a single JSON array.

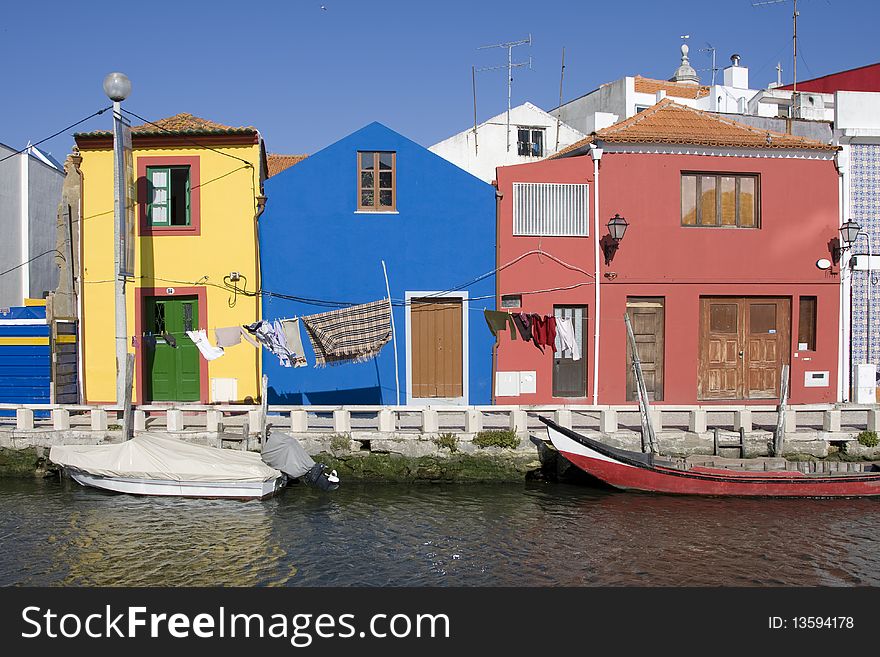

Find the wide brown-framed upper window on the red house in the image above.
[{"left": 681, "top": 173, "right": 760, "bottom": 228}]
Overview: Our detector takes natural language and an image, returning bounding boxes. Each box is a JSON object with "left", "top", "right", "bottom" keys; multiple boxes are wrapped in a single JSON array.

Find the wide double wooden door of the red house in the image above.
[{"left": 698, "top": 297, "right": 791, "bottom": 399}]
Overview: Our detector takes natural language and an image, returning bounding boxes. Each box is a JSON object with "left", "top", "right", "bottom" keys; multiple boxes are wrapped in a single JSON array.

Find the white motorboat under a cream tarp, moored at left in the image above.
[{"left": 49, "top": 433, "right": 286, "bottom": 499}]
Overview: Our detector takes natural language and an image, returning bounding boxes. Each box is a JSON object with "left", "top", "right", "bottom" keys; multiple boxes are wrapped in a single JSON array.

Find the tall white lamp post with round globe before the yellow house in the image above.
[{"left": 104, "top": 72, "right": 134, "bottom": 405}]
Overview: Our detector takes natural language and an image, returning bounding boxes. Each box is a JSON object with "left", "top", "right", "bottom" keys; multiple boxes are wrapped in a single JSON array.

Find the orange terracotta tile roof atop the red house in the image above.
[{"left": 551, "top": 98, "right": 837, "bottom": 159}]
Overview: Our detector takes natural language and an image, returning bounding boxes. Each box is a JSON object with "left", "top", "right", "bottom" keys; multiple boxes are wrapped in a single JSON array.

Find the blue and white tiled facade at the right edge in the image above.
[{"left": 850, "top": 144, "right": 880, "bottom": 368}]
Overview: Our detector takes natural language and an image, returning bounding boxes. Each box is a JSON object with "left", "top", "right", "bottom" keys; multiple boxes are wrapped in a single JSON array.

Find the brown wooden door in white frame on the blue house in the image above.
[{"left": 410, "top": 298, "right": 464, "bottom": 399}]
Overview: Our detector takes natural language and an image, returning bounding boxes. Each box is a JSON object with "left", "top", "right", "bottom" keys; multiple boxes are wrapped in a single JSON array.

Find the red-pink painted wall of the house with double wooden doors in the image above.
[{"left": 496, "top": 153, "right": 839, "bottom": 404}]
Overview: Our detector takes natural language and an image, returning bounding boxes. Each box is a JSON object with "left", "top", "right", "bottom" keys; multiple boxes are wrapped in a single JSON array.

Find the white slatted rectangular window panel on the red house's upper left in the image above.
[{"left": 513, "top": 183, "right": 590, "bottom": 237}]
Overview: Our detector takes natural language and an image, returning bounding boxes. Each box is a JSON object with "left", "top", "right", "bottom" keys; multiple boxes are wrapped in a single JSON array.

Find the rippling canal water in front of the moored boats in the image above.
[{"left": 0, "top": 479, "right": 880, "bottom": 586}]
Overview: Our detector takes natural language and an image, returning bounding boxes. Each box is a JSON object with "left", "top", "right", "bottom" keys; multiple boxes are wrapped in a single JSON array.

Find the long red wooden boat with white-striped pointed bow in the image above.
[{"left": 540, "top": 417, "right": 880, "bottom": 497}]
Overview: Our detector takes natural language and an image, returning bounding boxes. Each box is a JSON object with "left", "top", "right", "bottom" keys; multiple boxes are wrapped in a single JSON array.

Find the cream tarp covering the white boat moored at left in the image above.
[{"left": 49, "top": 433, "right": 281, "bottom": 482}]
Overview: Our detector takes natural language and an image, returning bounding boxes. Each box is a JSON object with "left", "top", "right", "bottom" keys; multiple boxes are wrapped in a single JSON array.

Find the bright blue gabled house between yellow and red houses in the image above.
[{"left": 259, "top": 123, "right": 495, "bottom": 405}]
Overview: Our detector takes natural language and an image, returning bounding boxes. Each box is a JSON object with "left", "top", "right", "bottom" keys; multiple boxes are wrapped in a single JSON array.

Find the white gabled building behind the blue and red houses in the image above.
[{"left": 428, "top": 103, "right": 586, "bottom": 183}]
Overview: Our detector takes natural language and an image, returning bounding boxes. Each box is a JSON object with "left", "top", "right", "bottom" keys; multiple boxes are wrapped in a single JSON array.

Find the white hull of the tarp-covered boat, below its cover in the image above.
[{"left": 64, "top": 467, "right": 286, "bottom": 500}]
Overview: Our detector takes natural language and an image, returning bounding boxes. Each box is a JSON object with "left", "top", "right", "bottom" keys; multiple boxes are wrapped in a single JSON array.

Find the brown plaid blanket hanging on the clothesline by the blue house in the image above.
[{"left": 300, "top": 299, "right": 391, "bottom": 367}]
